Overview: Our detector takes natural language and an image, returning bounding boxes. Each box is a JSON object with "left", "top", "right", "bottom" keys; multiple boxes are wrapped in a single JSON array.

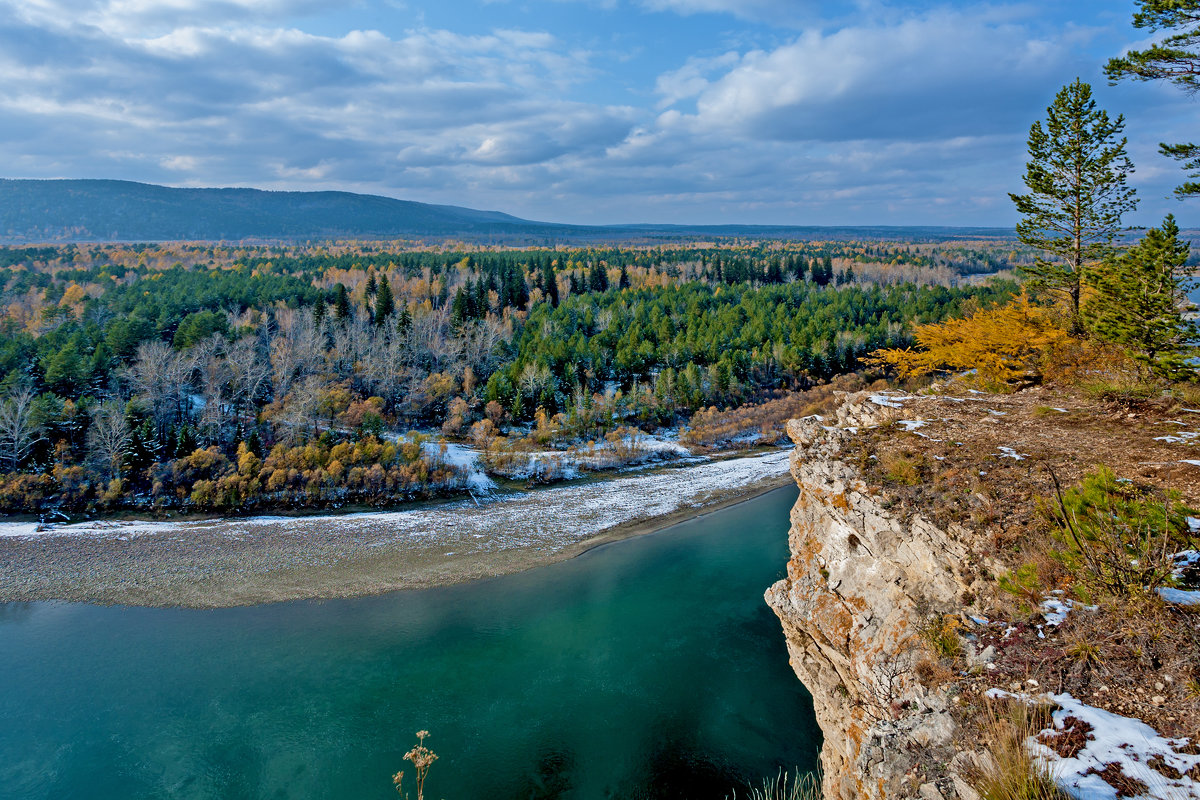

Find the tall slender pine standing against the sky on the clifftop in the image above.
[{"left": 1009, "top": 78, "right": 1138, "bottom": 333}]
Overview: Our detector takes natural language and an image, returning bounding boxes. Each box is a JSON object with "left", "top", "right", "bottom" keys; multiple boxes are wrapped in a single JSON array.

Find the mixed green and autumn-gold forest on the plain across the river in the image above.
[{"left": 0, "top": 241, "right": 1012, "bottom": 513}]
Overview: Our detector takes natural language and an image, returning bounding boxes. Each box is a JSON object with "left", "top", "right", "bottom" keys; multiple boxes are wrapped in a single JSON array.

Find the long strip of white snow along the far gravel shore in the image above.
[{"left": 0, "top": 449, "right": 791, "bottom": 553}]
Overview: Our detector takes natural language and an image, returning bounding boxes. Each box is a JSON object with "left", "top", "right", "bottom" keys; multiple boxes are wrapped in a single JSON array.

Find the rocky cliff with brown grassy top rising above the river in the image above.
[{"left": 766, "top": 386, "right": 1200, "bottom": 800}]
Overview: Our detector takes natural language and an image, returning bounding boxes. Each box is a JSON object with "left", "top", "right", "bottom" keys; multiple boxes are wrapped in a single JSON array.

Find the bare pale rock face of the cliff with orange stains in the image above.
[{"left": 766, "top": 393, "right": 977, "bottom": 800}]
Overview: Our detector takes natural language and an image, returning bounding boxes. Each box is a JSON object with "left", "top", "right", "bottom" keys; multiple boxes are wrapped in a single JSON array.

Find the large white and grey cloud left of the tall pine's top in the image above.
[{"left": 659, "top": 11, "right": 1069, "bottom": 140}]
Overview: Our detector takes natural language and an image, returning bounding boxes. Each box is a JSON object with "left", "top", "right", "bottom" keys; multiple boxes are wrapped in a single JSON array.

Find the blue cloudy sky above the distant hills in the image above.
[{"left": 0, "top": 0, "right": 1200, "bottom": 227}]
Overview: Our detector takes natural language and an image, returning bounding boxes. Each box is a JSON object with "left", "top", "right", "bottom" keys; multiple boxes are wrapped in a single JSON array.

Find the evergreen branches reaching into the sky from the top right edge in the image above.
[{"left": 1104, "top": 0, "right": 1200, "bottom": 199}]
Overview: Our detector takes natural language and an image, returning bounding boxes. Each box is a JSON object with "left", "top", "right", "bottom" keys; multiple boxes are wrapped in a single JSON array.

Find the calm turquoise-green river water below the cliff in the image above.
[{"left": 0, "top": 489, "right": 820, "bottom": 800}]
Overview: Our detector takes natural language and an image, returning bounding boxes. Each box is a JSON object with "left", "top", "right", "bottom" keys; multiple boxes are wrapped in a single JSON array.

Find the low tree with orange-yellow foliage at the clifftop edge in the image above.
[{"left": 866, "top": 294, "right": 1068, "bottom": 389}]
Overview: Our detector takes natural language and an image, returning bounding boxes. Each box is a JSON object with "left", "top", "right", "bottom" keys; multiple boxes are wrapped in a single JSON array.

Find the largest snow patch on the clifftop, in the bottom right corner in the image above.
[{"left": 988, "top": 688, "right": 1200, "bottom": 800}]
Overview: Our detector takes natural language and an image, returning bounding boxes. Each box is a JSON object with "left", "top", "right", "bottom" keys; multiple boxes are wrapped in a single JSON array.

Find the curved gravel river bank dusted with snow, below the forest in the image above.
[{"left": 0, "top": 451, "right": 791, "bottom": 608}]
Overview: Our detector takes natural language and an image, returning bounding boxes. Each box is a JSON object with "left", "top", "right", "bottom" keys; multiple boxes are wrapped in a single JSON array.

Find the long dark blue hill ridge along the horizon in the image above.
[{"left": 0, "top": 179, "right": 1013, "bottom": 245}]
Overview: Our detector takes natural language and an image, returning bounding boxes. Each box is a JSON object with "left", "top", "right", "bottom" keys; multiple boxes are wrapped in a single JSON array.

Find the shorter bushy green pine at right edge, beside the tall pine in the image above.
[{"left": 1087, "top": 216, "right": 1198, "bottom": 380}]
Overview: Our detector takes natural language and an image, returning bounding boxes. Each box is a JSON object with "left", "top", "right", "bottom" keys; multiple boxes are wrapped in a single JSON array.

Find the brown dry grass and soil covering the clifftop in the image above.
[{"left": 842, "top": 385, "right": 1200, "bottom": 736}]
